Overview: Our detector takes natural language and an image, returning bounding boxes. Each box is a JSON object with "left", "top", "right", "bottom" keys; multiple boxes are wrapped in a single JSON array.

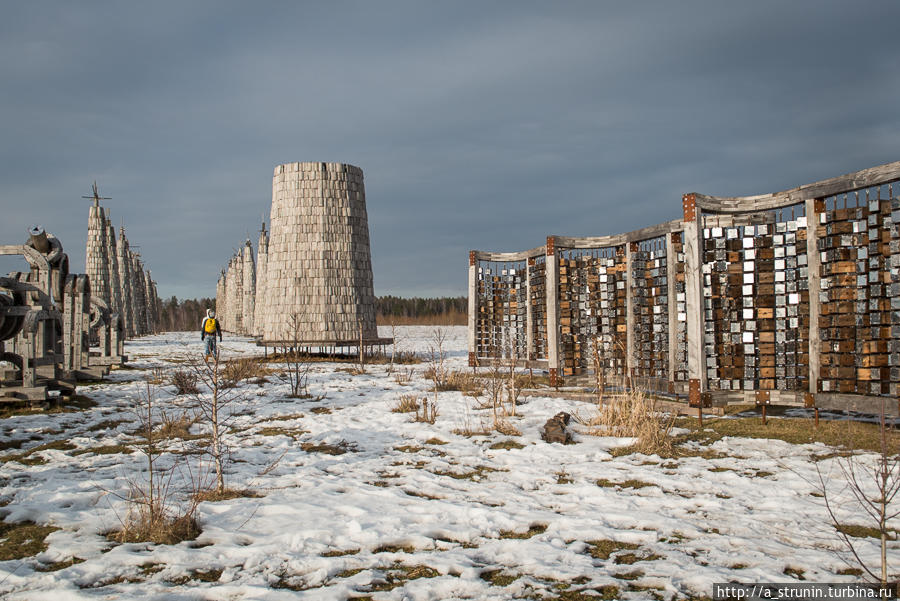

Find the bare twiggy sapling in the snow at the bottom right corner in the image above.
[{"left": 816, "top": 397, "right": 900, "bottom": 586}]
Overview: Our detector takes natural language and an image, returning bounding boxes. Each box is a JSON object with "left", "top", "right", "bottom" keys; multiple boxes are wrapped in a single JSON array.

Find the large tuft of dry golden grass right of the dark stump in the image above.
[{"left": 574, "top": 390, "right": 675, "bottom": 455}]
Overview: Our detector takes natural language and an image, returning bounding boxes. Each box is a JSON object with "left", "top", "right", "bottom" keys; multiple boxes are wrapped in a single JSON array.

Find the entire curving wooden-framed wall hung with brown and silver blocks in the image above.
[{"left": 469, "top": 162, "right": 900, "bottom": 413}]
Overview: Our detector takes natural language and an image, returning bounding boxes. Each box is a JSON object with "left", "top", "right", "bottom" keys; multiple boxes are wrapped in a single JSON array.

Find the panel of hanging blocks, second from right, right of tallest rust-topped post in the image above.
[{"left": 703, "top": 213, "right": 809, "bottom": 390}]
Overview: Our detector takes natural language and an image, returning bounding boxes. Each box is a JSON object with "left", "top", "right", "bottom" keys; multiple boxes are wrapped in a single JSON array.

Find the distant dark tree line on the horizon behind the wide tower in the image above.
[{"left": 159, "top": 296, "right": 468, "bottom": 332}]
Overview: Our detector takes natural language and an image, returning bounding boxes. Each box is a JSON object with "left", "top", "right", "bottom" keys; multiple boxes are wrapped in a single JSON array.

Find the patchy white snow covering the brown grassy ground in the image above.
[{"left": 0, "top": 327, "right": 896, "bottom": 601}]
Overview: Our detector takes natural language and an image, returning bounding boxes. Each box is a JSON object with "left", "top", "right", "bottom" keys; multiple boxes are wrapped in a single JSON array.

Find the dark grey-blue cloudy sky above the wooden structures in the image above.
[{"left": 0, "top": 0, "right": 900, "bottom": 298}]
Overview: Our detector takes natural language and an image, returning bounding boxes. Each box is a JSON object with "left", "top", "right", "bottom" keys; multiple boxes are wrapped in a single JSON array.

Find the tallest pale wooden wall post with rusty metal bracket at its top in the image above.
[{"left": 682, "top": 194, "right": 707, "bottom": 394}]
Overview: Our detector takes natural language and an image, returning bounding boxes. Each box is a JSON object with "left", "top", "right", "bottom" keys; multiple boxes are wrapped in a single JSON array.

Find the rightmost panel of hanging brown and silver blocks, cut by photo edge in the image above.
[{"left": 817, "top": 187, "right": 900, "bottom": 396}]
